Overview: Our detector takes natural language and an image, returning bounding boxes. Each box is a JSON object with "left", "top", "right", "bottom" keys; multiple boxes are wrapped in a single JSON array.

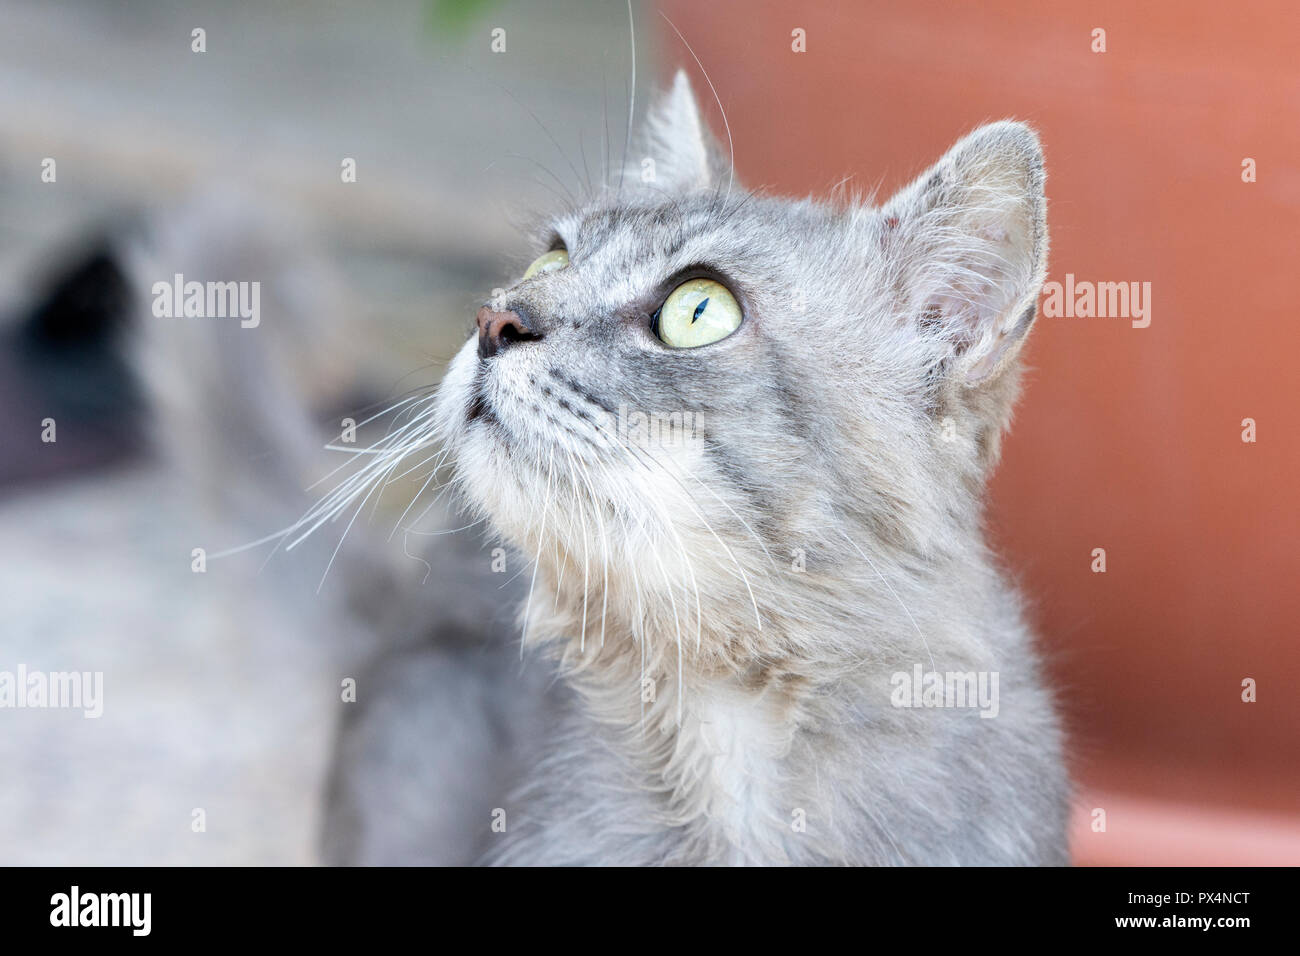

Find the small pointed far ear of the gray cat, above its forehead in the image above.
[{"left": 624, "top": 70, "right": 727, "bottom": 193}]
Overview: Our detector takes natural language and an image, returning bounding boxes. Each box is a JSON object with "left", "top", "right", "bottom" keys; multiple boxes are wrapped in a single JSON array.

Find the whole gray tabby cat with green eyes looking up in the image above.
[{"left": 326, "top": 74, "right": 1069, "bottom": 865}]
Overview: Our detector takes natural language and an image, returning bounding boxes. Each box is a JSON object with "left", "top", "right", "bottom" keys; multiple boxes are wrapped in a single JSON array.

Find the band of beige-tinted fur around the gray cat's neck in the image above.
[{"left": 525, "top": 515, "right": 987, "bottom": 686}]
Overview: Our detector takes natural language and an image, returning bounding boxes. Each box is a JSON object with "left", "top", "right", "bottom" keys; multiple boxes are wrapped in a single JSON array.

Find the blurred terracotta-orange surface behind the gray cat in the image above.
[{"left": 651, "top": 0, "right": 1300, "bottom": 864}]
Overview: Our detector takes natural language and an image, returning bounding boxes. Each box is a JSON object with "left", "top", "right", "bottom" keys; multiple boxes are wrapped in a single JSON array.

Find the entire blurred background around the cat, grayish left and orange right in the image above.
[{"left": 0, "top": 0, "right": 1300, "bottom": 865}]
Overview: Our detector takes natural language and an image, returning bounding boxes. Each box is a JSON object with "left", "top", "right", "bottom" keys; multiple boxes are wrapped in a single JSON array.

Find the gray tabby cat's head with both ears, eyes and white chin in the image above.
[{"left": 437, "top": 73, "right": 1047, "bottom": 650}]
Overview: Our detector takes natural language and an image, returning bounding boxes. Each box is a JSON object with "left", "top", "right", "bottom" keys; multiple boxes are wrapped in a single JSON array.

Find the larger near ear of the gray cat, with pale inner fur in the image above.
[{"left": 881, "top": 121, "right": 1048, "bottom": 386}]
